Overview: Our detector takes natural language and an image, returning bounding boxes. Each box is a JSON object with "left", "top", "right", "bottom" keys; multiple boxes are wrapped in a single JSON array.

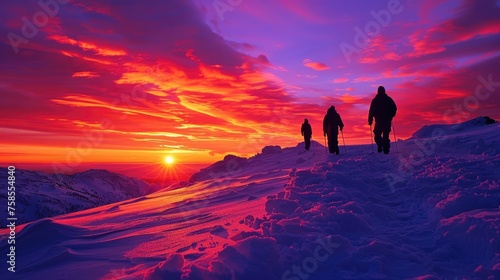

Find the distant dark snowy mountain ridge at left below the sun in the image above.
[{"left": 0, "top": 168, "right": 153, "bottom": 224}]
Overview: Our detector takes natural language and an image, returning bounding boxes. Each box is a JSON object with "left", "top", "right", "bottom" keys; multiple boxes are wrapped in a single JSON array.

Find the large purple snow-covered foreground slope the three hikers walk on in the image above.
[{"left": 0, "top": 119, "right": 500, "bottom": 280}]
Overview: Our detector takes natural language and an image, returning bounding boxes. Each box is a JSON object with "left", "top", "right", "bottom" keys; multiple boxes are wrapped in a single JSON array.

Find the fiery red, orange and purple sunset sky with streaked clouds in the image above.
[{"left": 0, "top": 0, "right": 500, "bottom": 171}]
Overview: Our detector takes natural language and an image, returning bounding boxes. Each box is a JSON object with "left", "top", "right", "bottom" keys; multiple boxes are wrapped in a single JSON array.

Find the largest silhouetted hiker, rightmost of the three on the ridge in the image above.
[{"left": 368, "top": 86, "right": 398, "bottom": 154}]
